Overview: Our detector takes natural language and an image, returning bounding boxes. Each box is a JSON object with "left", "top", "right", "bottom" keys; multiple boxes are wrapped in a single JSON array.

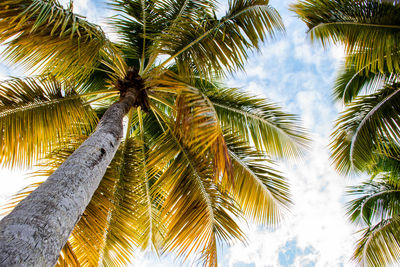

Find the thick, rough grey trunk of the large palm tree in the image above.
[{"left": 0, "top": 91, "right": 138, "bottom": 267}]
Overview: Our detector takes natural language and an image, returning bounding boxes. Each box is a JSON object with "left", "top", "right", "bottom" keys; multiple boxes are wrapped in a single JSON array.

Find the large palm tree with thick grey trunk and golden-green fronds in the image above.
[{"left": 0, "top": 0, "right": 306, "bottom": 266}]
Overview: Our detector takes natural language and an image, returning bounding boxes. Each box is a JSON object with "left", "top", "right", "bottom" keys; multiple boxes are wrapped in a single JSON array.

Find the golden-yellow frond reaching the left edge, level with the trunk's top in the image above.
[{"left": 0, "top": 78, "right": 97, "bottom": 167}]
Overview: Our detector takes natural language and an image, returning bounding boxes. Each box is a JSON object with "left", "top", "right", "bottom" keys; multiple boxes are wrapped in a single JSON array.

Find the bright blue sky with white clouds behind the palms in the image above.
[{"left": 0, "top": 0, "right": 366, "bottom": 267}]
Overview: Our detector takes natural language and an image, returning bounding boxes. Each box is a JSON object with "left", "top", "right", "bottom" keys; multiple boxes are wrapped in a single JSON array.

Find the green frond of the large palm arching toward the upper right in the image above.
[{"left": 154, "top": 0, "right": 283, "bottom": 77}]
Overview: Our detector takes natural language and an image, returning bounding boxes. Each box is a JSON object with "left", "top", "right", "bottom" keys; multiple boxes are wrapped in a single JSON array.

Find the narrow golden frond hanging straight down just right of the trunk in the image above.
[{"left": 100, "top": 138, "right": 162, "bottom": 266}]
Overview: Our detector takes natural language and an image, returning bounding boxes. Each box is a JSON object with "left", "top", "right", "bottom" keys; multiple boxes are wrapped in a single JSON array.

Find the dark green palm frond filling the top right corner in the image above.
[{"left": 291, "top": 0, "right": 400, "bottom": 72}]
